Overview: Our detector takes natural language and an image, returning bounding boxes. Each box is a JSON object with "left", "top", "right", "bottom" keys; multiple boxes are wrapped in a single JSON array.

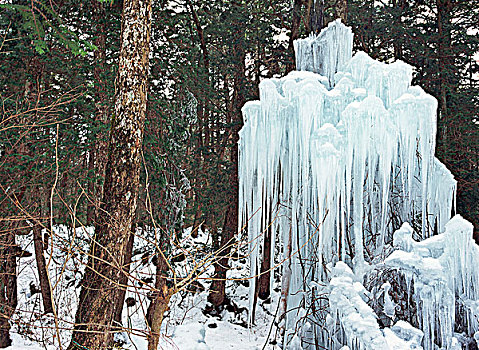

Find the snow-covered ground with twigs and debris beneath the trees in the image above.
[{"left": 8, "top": 226, "right": 279, "bottom": 350}]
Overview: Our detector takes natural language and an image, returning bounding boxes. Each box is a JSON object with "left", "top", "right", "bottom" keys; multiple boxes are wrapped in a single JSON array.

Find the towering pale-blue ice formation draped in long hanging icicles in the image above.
[{"left": 239, "top": 20, "right": 478, "bottom": 350}]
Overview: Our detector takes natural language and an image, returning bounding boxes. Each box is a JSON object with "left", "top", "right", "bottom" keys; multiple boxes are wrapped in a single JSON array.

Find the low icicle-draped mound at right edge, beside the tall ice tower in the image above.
[{"left": 385, "top": 215, "right": 479, "bottom": 349}]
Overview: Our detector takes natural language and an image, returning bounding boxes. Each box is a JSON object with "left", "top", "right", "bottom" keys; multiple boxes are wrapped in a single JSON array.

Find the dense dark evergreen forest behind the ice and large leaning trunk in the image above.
[{"left": 0, "top": 0, "right": 479, "bottom": 348}]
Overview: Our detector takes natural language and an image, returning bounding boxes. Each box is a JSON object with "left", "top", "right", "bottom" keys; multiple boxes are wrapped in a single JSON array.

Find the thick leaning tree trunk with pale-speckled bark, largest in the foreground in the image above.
[{"left": 69, "top": 0, "right": 151, "bottom": 350}]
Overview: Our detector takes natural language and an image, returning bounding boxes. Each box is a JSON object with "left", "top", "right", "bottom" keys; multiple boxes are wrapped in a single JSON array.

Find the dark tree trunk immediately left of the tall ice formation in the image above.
[{"left": 208, "top": 1, "right": 246, "bottom": 307}]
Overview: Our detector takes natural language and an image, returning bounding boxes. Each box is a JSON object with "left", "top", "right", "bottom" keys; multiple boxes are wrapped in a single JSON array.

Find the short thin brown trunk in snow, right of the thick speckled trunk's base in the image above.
[{"left": 146, "top": 253, "right": 172, "bottom": 350}]
